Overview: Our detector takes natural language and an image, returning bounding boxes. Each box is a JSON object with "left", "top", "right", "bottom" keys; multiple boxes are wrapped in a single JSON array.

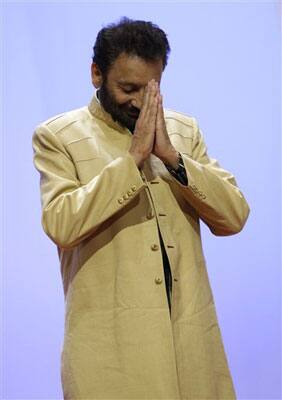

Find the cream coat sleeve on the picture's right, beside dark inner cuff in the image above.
[{"left": 167, "top": 119, "right": 249, "bottom": 236}]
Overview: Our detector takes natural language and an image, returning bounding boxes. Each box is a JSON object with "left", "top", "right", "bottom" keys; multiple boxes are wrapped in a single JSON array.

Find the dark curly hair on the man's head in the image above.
[{"left": 92, "top": 17, "right": 170, "bottom": 76}]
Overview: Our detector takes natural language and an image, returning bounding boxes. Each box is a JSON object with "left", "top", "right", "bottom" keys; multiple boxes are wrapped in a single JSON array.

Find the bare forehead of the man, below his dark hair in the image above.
[{"left": 107, "top": 53, "right": 163, "bottom": 86}]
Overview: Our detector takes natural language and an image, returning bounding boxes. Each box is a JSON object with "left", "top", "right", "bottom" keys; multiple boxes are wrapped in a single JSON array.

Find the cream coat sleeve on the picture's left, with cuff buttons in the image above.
[{"left": 32, "top": 126, "right": 145, "bottom": 248}]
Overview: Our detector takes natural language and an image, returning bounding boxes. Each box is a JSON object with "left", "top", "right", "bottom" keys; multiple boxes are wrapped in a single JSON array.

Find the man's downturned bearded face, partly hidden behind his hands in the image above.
[{"left": 92, "top": 53, "right": 163, "bottom": 132}]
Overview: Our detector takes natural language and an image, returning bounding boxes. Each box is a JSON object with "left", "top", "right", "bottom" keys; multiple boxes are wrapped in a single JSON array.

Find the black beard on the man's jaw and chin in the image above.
[{"left": 97, "top": 81, "right": 139, "bottom": 133}]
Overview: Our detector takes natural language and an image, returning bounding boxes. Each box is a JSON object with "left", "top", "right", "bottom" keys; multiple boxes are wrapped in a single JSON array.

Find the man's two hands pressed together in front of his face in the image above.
[{"left": 129, "top": 79, "right": 178, "bottom": 167}]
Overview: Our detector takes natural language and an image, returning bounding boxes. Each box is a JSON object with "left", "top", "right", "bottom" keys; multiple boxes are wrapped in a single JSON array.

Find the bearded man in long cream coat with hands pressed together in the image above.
[{"left": 33, "top": 18, "right": 249, "bottom": 400}]
